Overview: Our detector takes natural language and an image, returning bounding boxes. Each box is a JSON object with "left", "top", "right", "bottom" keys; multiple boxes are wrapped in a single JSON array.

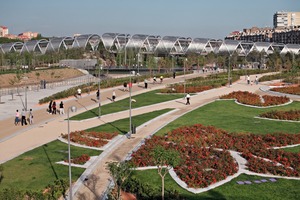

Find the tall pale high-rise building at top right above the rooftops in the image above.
[{"left": 273, "top": 11, "right": 300, "bottom": 28}]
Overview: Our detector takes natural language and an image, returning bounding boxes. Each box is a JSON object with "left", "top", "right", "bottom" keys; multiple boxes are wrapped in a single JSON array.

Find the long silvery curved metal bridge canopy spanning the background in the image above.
[{"left": 0, "top": 33, "right": 300, "bottom": 56}]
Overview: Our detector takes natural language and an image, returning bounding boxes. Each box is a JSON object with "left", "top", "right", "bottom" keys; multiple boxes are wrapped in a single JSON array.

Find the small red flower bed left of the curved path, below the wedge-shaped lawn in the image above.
[{"left": 62, "top": 131, "right": 118, "bottom": 147}]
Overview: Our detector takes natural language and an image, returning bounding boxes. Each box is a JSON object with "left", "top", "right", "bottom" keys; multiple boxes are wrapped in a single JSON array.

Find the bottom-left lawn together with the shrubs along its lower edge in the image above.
[{"left": 0, "top": 140, "right": 102, "bottom": 199}]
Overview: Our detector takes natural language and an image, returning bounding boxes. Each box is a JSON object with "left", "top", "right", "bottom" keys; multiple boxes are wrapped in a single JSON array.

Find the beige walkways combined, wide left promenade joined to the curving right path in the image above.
[{"left": 0, "top": 74, "right": 298, "bottom": 199}]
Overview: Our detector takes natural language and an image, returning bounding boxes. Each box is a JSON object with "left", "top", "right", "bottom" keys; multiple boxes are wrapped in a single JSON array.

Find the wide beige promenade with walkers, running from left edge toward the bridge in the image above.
[{"left": 0, "top": 73, "right": 207, "bottom": 159}]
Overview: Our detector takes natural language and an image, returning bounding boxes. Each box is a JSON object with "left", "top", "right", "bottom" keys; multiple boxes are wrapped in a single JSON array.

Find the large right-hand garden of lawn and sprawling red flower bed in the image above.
[{"left": 121, "top": 94, "right": 300, "bottom": 199}]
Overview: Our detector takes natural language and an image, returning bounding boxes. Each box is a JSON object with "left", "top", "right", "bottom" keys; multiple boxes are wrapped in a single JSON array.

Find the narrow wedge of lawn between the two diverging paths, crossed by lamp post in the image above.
[{"left": 86, "top": 108, "right": 173, "bottom": 134}]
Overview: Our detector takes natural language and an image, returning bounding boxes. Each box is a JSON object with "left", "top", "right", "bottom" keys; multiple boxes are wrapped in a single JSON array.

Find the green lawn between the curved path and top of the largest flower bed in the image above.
[{"left": 156, "top": 100, "right": 300, "bottom": 135}]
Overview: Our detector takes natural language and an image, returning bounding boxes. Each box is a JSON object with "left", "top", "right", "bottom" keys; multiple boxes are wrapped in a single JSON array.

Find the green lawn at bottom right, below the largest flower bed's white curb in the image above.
[{"left": 133, "top": 170, "right": 300, "bottom": 200}]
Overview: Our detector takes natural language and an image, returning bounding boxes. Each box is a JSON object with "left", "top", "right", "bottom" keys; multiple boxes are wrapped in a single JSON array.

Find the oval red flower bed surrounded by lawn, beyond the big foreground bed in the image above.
[{"left": 220, "top": 91, "right": 290, "bottom": 107}]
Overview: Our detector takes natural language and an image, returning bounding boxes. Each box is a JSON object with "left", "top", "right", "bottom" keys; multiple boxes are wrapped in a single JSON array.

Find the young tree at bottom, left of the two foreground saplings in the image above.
[{"left": 108, "top": 162, "right": 133, "bottom": 200}]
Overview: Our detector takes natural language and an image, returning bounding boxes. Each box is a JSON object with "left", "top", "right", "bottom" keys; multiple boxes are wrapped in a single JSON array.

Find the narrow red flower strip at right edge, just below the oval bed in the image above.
[{"left": 259, "top": 110, "right": 300, "bottom": 121}]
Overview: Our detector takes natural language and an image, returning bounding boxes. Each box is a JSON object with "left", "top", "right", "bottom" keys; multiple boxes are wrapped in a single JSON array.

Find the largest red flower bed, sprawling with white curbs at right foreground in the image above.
[{"left": 131, "top": 124, "right": 300, "bottom": 188}]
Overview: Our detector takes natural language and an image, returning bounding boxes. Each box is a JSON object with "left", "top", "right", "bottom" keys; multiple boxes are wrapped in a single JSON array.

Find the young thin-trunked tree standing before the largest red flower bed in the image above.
[{"left": 151, "top": 146, "right": 180, "bottom": 200}]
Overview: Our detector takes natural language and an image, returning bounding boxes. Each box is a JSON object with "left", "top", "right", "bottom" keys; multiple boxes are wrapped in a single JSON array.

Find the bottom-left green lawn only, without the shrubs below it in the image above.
[{"left": 0, "top": 140, "right": 102, "bottom": 191}]
